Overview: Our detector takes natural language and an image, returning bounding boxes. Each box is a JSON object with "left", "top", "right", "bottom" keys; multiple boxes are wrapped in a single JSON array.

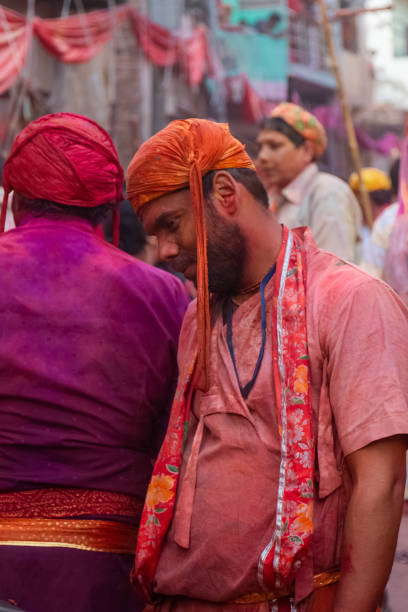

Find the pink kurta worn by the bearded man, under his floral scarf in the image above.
[{"left": 151, "top": 231, "right": 408, "bottom": 612}]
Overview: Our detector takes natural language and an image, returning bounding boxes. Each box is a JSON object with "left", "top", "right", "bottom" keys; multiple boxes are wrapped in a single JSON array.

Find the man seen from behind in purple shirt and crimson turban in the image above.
[{"left": 0, "top": 113, "right": 187, "bottom": 612}]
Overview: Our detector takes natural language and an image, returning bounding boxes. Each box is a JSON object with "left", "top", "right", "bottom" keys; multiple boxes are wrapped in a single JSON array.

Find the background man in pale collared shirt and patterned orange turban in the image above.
[{"left": 256, "top": 102, "right": 362, "bottom": 263}]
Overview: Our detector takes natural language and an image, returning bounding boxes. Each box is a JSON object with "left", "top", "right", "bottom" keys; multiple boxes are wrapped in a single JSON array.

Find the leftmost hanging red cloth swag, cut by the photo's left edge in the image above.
[{"left": 0, "top": 6, "right": 30, "bottom": 94}]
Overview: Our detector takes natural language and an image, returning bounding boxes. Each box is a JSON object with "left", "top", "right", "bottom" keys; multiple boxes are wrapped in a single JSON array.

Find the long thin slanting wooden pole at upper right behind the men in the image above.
[{"left": 318, "top": 0, "right": 373, "bottom": 228}]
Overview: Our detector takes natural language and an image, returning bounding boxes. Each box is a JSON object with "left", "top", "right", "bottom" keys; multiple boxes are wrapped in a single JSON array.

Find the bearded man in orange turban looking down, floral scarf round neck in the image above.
[{"left": 127, "top": 119, "right": 408, "bottom": 612}]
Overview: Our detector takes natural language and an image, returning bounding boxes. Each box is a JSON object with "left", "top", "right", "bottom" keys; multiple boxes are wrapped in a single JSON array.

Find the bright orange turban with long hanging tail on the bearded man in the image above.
[{"left": 126, "top": 119, "right": 255, "bottom": 389}]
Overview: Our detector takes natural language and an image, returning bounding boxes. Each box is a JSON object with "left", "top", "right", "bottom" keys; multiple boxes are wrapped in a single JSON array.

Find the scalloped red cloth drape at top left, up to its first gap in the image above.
[{"left": 0, "top": 6, "right": 213, "bottom": 94}]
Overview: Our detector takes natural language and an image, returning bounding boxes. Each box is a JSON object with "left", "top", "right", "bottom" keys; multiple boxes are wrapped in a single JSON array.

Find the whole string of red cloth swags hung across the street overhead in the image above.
[{"left": 0, "top": 5, "right": 401, "bottom": 155}]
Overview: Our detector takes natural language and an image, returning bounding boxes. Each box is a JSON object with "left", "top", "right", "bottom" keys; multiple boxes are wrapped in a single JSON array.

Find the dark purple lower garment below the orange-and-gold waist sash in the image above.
[{"left": 0, "top": 546, "right": 144, "bottom": 612}]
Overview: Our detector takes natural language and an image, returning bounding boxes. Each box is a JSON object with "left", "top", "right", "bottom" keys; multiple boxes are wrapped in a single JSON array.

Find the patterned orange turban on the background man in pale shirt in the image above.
[{"left": 269, "top": 102, "right": 327, "bottom": 157}]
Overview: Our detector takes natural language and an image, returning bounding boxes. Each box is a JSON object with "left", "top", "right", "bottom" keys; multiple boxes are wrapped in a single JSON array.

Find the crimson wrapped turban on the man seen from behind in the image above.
[{"left": 0, "top": 113, "right": 123, "bottom": 242}]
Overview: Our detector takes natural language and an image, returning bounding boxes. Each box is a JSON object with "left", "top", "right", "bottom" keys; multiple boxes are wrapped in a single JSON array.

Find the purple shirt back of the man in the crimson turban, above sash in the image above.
[{"left": 0, "top": 216, "right": 188, "bottom": 497}]
